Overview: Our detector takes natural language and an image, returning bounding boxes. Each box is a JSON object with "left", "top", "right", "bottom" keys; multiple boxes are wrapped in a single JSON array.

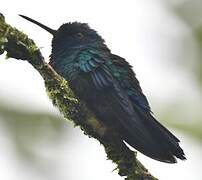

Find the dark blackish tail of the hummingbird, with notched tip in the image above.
[{"left": 122, "top": 107, "right": 186, "bottom": 163}]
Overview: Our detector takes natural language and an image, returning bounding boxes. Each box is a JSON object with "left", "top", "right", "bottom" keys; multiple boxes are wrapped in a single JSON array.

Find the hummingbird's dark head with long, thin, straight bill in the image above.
[{"left": 20, "top": 15, "right": 104, "bottom": 53}]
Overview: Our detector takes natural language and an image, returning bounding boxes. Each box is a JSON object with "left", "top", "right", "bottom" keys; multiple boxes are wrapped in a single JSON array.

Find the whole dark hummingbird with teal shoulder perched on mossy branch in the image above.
[{"left": 20, "top": 15, "right": 186, "bottom": 163}]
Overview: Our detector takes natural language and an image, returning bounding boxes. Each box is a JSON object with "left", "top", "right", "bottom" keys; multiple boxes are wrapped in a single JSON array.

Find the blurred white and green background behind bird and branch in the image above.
[{"left": 0, "top": 0, "right": 202, "bottom": 180}]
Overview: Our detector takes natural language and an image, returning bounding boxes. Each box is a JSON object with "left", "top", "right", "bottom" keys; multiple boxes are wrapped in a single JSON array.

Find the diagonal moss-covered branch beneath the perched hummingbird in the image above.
[{"left": 0, "top": 14, "right": 156, "bottom": 180}]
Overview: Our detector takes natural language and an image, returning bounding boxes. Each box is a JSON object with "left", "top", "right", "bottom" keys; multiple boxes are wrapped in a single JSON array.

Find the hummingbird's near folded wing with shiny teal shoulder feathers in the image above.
[{"left": 77, "top": 50, "right": 163, "bottom": 155}]
